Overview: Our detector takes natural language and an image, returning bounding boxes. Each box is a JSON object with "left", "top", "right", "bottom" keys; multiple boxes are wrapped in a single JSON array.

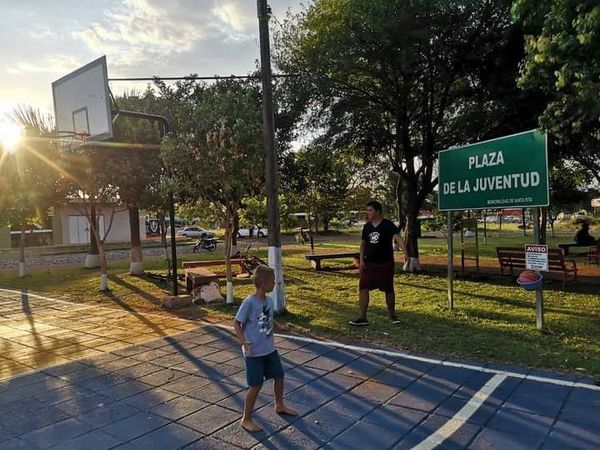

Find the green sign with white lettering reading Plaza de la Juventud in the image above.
[{"left": 439, "top": 130, "right": 549, "bottom": 211}]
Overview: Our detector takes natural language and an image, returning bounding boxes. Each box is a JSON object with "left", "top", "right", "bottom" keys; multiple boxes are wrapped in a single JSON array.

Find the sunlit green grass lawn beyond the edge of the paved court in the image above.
[{"left": 0, "top": 236, "right": 600, "bottom": 378}]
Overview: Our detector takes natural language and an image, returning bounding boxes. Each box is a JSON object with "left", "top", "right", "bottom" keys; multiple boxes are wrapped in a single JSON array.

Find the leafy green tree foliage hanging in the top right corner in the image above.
[{"left": 513, "top": 0, "right": 600, "bottom": 182}]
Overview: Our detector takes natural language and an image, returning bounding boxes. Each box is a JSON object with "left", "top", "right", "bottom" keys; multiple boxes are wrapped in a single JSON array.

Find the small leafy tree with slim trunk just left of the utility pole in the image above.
[{"left": 159, "top": 80, "right": 264, "bottom": 303}]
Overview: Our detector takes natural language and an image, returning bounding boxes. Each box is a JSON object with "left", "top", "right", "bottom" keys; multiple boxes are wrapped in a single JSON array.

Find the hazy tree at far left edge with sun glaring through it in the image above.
[{"left": 0, "top": 107, "right": 60, "bottom": 277}]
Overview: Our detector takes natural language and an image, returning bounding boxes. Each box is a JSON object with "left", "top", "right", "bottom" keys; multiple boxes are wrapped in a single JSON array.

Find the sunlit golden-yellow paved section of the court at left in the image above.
[{"left": 0, "top": 289, "right": 196, "bottom": 381}]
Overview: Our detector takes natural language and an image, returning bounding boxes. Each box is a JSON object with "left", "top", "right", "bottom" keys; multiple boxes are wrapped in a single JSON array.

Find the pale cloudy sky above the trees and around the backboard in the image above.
[{"left": 0, "top": 0, "right": 306, "bottom": 115}]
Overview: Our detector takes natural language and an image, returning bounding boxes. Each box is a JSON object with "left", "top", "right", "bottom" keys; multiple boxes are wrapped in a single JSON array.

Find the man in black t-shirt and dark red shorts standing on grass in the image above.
[{"left": 349, "top": 201, "right": 408, "bottom": 326}]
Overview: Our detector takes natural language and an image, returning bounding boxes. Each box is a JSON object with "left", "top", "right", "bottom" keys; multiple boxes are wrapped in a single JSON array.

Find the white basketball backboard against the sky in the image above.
[{"left": 52, "top": 56, "right": 113, "bottom": 141}]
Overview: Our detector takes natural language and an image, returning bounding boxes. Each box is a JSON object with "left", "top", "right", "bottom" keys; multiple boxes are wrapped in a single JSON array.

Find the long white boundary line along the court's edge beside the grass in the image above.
[{"left": 0, "top": 288, "right": 600, "bottom": 391}]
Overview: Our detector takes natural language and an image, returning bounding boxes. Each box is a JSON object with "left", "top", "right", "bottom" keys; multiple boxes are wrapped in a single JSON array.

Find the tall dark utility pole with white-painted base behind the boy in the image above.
[{"left": 257, "top": 0, "right": 285, "bottom": 313}]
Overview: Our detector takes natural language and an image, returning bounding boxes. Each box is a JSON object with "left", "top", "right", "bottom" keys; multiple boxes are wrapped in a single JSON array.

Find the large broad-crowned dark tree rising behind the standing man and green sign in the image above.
[{"left": 276, "top": 0, "right": 515, "bottom": 270}]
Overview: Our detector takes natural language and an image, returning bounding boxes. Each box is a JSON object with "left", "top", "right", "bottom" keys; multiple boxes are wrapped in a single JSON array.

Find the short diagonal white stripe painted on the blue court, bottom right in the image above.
[{"left": 413, "top": 374, "right": 506, "bottom": 450}]
